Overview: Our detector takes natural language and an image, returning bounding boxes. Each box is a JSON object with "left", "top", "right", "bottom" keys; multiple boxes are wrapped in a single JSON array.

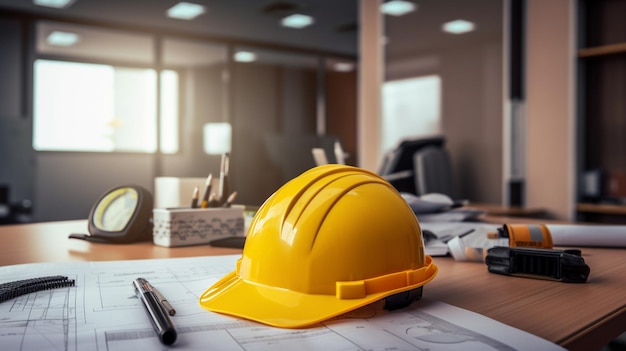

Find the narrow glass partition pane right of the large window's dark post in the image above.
[{"left": 161, "top": 36, "right": 231, "bottom": 177}]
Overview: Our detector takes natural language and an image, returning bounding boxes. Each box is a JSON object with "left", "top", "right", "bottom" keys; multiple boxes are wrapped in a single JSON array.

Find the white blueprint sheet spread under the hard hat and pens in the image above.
[{"left": 0, "top": 255, "right": 562, "bottom": 351}]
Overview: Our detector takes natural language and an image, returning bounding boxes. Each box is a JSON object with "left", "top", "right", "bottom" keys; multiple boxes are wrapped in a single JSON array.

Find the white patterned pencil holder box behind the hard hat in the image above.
[{"left": 152, "top": 205, "right": 245, "bottom": 247}]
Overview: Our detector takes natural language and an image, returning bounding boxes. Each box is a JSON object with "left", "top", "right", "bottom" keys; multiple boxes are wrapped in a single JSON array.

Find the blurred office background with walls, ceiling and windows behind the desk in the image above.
[{"left": 0, "top": 0, "right": 608, "bottom": 222}]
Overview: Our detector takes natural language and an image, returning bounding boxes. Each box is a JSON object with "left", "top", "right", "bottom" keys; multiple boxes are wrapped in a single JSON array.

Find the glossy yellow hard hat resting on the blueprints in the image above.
[{"left": 200, "top": 164, "right": 437, "bottom": 328}]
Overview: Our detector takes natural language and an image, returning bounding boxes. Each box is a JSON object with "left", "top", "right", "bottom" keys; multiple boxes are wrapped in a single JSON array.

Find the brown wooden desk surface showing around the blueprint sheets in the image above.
[{"left": 0, "top": 220, "right": 626, "bottom": 350}]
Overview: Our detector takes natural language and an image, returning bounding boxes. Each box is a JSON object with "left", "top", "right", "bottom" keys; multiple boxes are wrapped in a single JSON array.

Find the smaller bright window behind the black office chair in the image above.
[{"left": 381, "top": 75, "right": 441, "bottom": 154}]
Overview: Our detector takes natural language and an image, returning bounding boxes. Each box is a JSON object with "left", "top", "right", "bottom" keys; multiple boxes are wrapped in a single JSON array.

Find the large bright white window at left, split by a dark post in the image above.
[{"left": 33, "top": 60, "right": 178, "bottom": 153}]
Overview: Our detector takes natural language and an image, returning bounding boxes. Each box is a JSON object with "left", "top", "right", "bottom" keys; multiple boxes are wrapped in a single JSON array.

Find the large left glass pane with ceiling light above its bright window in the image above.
[{"left": 33, "top": 21, "right": 179, "bottom": 153}]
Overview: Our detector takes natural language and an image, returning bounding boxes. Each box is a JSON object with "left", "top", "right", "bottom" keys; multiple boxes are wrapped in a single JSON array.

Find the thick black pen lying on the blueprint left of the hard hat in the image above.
[{"left": 133, "top": 278, "right": 177, "bottom": 345}]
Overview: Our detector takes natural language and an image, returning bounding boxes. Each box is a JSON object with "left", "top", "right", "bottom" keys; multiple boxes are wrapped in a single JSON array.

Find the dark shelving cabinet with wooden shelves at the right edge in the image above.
[{"left": 577, "top": 0, "right": 626, "bottom": 223}]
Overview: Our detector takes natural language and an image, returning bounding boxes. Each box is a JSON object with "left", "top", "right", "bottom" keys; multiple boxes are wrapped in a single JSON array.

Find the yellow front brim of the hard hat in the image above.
[{"left": 200, "top": 257, "right": 438, "bottom": 328}]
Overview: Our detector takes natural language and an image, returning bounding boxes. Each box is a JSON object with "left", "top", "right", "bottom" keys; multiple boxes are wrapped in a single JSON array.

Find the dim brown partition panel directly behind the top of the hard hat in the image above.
[{"left": 231, "top": 64, "right": 316, "bottom": 204}]
